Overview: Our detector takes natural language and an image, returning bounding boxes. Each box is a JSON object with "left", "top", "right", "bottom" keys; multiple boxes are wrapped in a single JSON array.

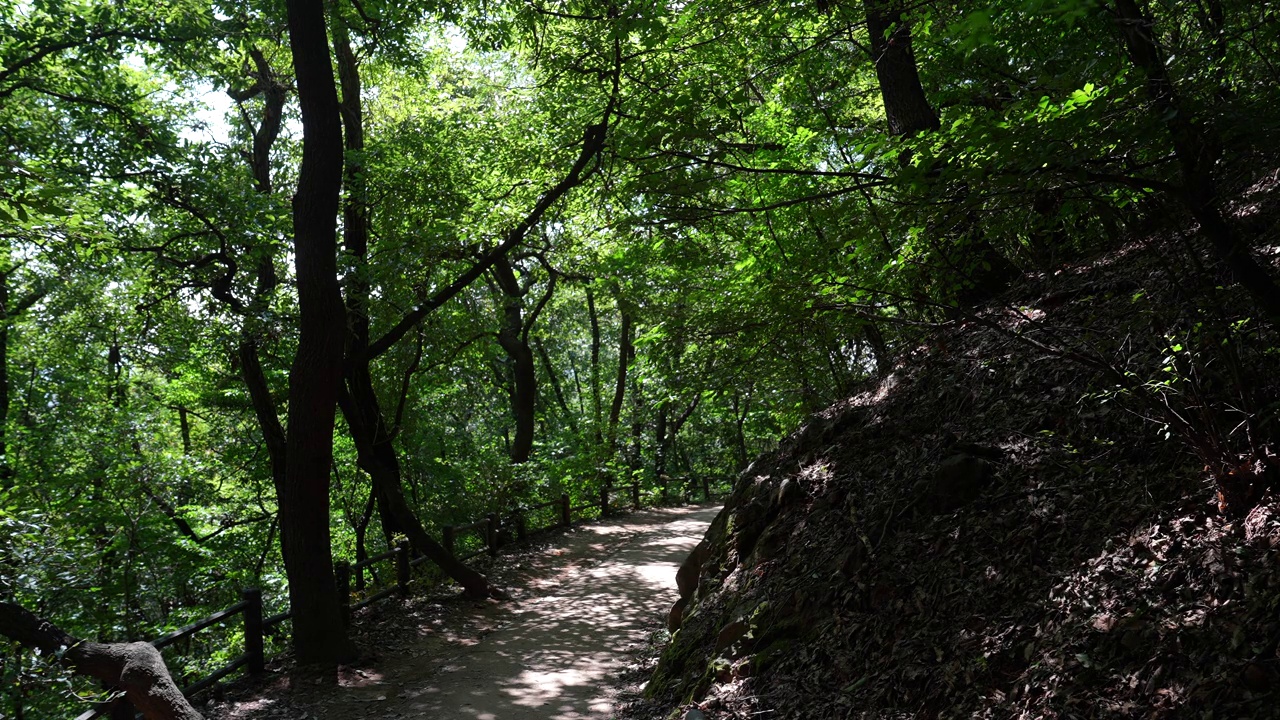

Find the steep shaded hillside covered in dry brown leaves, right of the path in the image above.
[{"left": 641, "top": 181, "right": 1280, "bottom": 720}]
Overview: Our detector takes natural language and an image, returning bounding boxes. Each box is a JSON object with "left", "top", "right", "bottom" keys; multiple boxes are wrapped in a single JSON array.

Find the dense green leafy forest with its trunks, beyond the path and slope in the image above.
[{"left": 0, "top": 0, "right": 1280, "bottom": 712}]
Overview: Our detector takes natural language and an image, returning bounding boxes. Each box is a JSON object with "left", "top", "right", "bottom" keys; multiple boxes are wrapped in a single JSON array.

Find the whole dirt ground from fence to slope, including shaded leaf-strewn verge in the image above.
[{"left": 202, "top": 505, "right": 719, "bottom": 720}]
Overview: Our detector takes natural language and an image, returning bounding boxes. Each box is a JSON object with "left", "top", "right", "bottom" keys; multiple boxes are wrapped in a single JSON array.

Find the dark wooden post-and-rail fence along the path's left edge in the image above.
[{"left": 76, "top": 478, "right": 712, "bottom": 720}]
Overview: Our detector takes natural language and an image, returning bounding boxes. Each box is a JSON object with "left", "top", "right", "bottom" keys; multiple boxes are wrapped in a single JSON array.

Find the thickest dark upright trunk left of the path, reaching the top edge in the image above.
[{"left": 279, "top": 0, "right": 356, "bottom": 666}]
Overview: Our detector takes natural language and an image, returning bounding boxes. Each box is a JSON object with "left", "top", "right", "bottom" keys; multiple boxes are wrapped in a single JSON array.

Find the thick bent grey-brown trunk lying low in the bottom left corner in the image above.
[{"left": 0, "top": 602, "right": 201, "bottom": 720}]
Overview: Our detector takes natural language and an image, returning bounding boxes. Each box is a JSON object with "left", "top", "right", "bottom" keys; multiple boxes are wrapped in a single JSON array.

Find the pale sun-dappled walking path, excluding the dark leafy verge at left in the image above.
[{"left": 303, "top": 507, "right": 718, "bottom": 720}]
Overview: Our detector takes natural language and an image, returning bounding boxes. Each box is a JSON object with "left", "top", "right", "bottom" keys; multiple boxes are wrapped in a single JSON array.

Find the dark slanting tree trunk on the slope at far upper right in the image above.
[{"left": 1115, "top": 0, "right": 1280, "bottom": 323}]
